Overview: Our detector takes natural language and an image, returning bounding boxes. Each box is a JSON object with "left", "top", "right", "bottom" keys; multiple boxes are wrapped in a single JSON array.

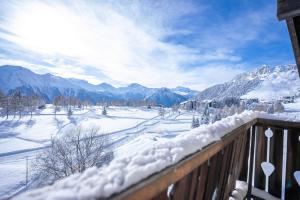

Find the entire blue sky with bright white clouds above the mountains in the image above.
[{"left": 0, "top": 0, "right": 294, "bottom": 90}]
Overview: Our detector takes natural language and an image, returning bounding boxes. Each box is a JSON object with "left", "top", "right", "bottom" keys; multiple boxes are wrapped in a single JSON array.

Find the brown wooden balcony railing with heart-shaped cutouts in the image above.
[{"left": 109, "top": 118, "right": 300, "bottom": 200}]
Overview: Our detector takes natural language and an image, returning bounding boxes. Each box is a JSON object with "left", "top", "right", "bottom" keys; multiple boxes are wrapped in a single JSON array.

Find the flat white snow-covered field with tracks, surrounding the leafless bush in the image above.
[{"left": 0, "top": 105, "right": 194, "bottom": 199}]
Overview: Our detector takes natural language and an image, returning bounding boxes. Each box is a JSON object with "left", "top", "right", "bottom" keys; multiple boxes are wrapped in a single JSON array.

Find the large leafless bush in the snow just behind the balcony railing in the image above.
[{"left": 33, "top": 127, "right": 113, "bottom": 185}]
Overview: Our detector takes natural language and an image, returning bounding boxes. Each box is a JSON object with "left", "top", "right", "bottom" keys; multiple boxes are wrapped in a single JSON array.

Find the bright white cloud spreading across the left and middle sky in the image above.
[{"left": 0, "top": 1, "right": 278, "bottom": 89}]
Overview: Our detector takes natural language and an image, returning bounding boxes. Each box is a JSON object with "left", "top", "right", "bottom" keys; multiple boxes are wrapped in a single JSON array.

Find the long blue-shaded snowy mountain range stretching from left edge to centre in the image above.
[{"left": 0, "top": 65, "right": 197, "bottom": 106}]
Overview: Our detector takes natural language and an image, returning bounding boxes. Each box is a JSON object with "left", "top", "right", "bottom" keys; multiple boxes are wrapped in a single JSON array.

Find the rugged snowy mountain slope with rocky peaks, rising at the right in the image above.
[{"left": 195, "top": 65, "right": 300, "bottom": 100}]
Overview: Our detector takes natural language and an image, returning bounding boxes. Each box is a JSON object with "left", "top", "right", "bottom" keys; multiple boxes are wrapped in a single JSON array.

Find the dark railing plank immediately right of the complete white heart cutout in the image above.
[{"left": 269, "top": 129, "right": 283, "bottom": 198}]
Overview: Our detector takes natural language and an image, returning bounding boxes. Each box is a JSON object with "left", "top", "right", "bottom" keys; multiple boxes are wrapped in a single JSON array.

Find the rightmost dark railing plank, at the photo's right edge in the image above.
[{"left": 285, "top": 130, "right": 300, "bottom": 199}]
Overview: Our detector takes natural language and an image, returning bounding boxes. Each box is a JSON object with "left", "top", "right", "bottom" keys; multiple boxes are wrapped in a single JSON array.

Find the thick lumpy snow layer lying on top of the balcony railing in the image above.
[{"left": 15, "top": 111, "right": 298, "bottom": 200}]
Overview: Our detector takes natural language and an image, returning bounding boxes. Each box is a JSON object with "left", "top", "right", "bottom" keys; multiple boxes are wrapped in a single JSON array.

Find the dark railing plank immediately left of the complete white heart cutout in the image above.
[{"left": 254, "top": 126, "right": 267, "bottom": 190}]
